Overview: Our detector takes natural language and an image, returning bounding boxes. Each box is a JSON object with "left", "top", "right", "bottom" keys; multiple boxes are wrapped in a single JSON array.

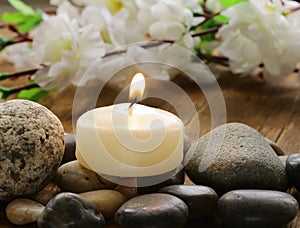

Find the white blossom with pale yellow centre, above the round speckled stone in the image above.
[{"left": 32, "top": 14, "right": 105, "bottom": 90}]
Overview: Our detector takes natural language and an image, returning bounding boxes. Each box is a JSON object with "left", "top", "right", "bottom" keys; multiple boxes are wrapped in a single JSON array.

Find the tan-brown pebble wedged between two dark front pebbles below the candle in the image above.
[{"left": 79, "top": 190, "right": 128, "bottom": 218}]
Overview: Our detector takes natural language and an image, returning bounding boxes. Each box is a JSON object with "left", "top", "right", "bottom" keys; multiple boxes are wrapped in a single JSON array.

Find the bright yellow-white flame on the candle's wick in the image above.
[{"left": 129, "top": 73, "right": 145, "bottom": 102}]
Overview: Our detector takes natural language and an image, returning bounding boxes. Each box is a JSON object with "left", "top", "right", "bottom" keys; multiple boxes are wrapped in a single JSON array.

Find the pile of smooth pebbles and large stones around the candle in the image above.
[{"left": 0, "top": 101, "right": 300, "bottom": 228}]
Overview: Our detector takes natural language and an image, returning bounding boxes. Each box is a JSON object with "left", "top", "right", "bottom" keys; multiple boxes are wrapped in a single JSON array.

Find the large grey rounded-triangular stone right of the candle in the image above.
[{"left": 185, "top": 123, "right": 289, "bottom": 194}]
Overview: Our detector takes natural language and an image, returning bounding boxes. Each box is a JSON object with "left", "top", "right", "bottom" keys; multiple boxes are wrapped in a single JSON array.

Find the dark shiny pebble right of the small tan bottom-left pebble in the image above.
[{"left": 38, "top": 193, "right": 105, "bottom": 228}]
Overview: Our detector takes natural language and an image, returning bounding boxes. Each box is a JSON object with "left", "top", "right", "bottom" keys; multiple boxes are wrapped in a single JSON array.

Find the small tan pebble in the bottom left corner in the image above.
[{"left": 5, "top": 198, "right": 44, "bottom": 225}]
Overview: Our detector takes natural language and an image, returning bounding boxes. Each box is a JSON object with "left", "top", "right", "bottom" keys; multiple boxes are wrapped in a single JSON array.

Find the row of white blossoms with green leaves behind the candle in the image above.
[{"left": 0, "top": 0, "right": 300, "bottom": 99}]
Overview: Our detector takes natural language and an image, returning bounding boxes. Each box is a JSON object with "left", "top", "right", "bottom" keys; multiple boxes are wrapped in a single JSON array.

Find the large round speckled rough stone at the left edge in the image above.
[{"left": 0, "top": 100, "right": 64, "bottom": 201}]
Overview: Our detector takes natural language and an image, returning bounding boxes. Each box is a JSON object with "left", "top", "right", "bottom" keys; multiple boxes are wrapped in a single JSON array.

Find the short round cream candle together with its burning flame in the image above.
[{"left": 76, "top": 74, "right": 184, "bottom": 177}]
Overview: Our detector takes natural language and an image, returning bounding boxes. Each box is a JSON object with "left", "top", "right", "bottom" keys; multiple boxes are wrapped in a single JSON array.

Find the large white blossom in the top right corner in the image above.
[{"left": 220, "top": 0, "right": 300, "bottom": 76}]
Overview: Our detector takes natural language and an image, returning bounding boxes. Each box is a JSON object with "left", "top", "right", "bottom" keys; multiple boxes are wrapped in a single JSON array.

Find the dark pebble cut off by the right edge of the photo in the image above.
[{"left": 286, "top": 153, "right": 300, "bottom": 191}]
